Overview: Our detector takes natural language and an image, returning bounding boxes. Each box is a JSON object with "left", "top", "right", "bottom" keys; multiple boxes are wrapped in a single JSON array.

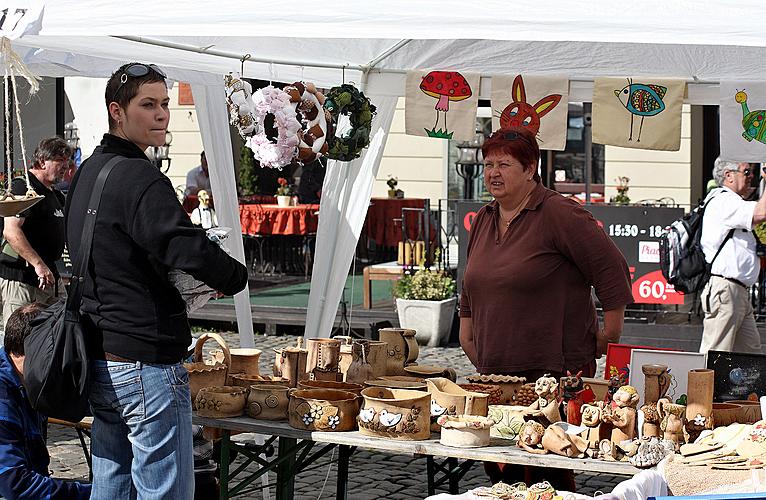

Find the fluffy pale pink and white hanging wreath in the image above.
[{"left": 247, "top": 85, "right": 301, "bottom": 168}]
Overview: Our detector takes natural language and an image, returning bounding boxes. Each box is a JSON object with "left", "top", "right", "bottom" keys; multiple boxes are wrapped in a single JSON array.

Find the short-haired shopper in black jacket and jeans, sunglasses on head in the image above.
[{"left": 66, "top": 63, "right": 247, "bottom": 500}]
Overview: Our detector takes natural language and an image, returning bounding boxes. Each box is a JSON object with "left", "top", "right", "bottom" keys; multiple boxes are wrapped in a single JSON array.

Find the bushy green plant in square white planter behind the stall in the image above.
[{"left": 394, "top": 268, "right": 457, "bottom": 347}]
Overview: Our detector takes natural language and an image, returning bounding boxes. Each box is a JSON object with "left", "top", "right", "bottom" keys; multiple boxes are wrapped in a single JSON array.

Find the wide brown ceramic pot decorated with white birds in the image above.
[{"left": 357, "top": 387, "right": 431, "bottom": 441}]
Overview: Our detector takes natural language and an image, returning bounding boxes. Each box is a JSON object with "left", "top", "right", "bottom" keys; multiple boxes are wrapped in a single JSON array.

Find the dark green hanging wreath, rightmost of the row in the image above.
[{"left": 324, "top": 83, "right": 375, "bottom": 161}]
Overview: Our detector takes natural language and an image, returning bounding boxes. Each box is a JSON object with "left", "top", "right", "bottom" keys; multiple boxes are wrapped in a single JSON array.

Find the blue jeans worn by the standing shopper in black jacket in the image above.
[{"left": 90, "top": 360, "right": 194, "bottom": 500}]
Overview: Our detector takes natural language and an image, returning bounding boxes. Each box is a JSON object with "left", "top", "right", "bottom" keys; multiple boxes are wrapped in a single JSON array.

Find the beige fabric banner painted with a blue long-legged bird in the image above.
[{"left": 593, "top": 77, "right": 686, "bottom": 151}]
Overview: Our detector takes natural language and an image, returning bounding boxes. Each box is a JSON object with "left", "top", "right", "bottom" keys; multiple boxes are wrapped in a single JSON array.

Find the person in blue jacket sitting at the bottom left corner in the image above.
[{"left": 0, "top": 302, "right": 91, "bottom": 500}]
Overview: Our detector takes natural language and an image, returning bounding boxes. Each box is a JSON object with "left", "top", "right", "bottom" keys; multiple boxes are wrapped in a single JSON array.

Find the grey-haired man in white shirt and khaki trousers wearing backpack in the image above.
[{"left": 700, "top": 158, "right": 766, "bottom": 353}]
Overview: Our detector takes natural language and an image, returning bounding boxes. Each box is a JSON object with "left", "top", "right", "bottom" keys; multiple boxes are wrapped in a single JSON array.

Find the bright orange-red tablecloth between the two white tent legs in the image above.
[{"left": 239, "top": 204, "right": 319, "bottom": 236}]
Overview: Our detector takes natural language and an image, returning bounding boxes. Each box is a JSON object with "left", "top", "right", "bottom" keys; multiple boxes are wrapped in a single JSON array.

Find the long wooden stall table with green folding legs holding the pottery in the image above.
[{"left": 193, "top": 414, "right": 639, "bottom": 500}]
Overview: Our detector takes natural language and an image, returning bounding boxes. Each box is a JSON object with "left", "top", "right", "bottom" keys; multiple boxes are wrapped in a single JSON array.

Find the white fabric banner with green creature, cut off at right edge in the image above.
[{"left": 718, "top": 81, "right": 766, "bottom": 163}]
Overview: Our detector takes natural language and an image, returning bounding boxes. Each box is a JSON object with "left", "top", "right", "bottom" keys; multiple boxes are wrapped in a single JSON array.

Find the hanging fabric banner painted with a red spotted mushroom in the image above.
[{"left": 404, "top": 71, "right": 479, "bottom": 141}]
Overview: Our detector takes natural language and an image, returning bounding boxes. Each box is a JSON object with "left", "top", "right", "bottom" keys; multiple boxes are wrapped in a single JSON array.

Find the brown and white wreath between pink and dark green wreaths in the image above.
[{"left": 284, "top": 82, "right": 328, "bottom": 163}]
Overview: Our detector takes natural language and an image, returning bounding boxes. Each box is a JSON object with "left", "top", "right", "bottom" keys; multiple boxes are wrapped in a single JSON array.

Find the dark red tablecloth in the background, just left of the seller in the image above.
[{"left": 365, "top": 198, "right": 433, "bottom": 247}]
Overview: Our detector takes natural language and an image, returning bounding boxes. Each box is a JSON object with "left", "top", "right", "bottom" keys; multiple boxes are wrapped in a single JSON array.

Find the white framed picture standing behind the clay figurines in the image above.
[{"left": 630, "top": 349, "right": 706, "bottom": 407}]
